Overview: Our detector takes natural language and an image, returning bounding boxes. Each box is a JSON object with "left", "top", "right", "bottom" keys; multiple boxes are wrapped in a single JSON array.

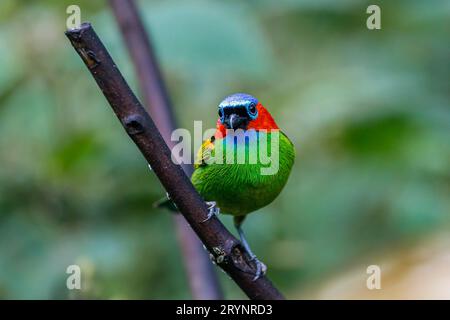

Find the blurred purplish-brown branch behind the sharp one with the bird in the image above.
[{"left": 109, "top": 0, "right": 223, "bottom": 300}]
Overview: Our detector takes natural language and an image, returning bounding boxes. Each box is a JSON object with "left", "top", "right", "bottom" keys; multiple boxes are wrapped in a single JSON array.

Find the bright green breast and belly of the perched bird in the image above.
[{"left": 192, "top": 132, "right": 295, "bottom": 215}]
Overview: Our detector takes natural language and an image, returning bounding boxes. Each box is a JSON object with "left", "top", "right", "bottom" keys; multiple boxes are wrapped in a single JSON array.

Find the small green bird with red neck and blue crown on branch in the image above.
[{"left": 191, "top": 93, "right": 295, "bottom": 280}]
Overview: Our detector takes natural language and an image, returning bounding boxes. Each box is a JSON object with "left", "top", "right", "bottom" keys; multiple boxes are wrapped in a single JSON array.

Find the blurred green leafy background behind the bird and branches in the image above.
[{"left": 0, "top": 0, "right": 450, "bottom": 299}]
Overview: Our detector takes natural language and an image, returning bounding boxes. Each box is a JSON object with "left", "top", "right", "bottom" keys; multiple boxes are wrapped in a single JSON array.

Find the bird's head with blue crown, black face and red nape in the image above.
[{"left": 217, "top": 93, "right": 278, "bottom": 137}]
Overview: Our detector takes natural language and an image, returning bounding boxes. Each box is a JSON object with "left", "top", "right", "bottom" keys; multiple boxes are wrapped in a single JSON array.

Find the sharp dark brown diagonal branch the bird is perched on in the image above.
[{"left": 66, "top": 23, "right": 283, "bottom": 299}]
